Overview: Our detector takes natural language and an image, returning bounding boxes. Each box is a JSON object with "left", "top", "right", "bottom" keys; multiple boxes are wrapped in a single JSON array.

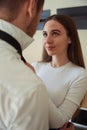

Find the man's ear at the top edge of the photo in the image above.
[{"left": 28, "top": 0, "right": 38, "bottom": 18}]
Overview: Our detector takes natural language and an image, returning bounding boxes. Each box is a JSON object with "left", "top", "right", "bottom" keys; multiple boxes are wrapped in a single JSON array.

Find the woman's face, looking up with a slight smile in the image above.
[{"left": 43, "top": 20, "right": 71, "bottom": 56}]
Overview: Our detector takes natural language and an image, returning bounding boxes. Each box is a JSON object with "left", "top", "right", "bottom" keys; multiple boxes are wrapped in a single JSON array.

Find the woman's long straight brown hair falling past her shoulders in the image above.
[{"left": 41, "top": 14, "right": 85, "bottom": 68}]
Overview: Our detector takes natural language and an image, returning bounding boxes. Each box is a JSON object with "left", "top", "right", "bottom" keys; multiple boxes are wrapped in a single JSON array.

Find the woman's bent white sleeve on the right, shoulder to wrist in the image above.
[{"left": 49, "top": 73, "right": 87, "bottom": 128}]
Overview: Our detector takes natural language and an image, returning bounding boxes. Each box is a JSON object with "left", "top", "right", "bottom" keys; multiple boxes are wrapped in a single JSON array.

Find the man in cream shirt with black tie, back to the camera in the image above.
[{"left": 0, "top": 0, "right": 73, "bottom": 130}]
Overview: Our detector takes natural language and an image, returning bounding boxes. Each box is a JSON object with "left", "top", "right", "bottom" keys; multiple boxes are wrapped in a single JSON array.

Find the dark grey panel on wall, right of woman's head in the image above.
[{"left": 57, "top": 6, "right": 87, "bottom": 29}]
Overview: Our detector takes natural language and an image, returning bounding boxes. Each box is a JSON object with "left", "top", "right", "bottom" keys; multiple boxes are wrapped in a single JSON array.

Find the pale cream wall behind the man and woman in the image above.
[{"left": 23, "top": 0, "right": 87, "bottom": 66}]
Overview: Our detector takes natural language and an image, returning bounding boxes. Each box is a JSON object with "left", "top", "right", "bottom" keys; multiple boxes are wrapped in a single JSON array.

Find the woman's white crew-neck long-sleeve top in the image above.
[{"left": 32, "top": 62, "right": 87, "bottom": 128}]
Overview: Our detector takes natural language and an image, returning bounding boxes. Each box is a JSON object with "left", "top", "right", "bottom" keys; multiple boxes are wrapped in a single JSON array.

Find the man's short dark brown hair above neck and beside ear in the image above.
[{"left": 0, "top": 0, "right": 44, "bottom": 21}]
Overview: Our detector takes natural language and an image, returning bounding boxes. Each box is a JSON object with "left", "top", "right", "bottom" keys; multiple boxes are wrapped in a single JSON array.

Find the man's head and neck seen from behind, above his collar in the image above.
[{"left": 0, "top": 0, "right": 44, "bottom": 36}]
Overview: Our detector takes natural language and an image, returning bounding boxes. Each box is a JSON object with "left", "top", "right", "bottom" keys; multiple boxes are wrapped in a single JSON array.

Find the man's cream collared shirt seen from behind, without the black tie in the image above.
[{"left": 0, "top": 20, "right": 48, "bottom": 130}]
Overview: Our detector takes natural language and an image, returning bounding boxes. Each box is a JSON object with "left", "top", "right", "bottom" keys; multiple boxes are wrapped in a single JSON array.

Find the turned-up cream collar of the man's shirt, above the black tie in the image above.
[{"left": 0, "top": 19, "right": 34, "bottom": 50}]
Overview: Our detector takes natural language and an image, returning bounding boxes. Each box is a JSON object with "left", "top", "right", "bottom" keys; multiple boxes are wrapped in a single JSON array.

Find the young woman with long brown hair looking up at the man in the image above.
[{"left": 32, "top": 15, "right": 87, "bottom": 128}]
